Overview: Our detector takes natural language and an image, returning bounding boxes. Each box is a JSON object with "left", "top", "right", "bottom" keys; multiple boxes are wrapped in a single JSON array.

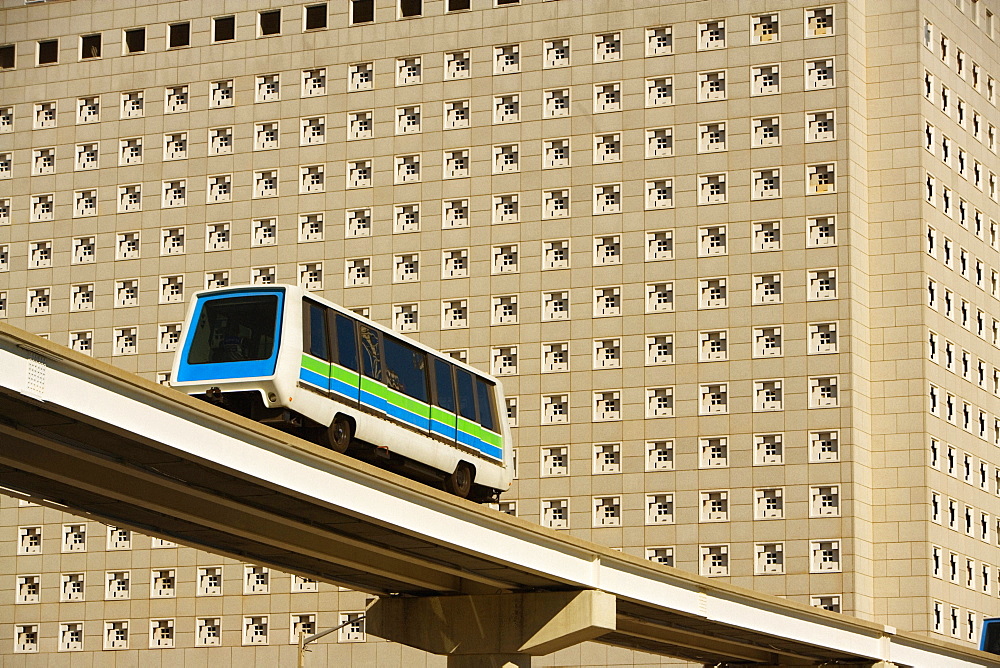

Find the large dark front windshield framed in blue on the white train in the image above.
[{"left": 188, "top": 295, "right": 278, "bottom": 364}]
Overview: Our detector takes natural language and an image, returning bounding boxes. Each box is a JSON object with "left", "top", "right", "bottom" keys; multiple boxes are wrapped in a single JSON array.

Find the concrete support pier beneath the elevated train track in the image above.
[{"left": 366, "top": 589, "right": 616, "bottom": 668}]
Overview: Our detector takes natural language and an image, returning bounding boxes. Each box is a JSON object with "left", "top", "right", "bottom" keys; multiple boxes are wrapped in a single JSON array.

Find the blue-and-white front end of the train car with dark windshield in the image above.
[{"left": 170, "top": 286, "right": 296, "bottom": 419}]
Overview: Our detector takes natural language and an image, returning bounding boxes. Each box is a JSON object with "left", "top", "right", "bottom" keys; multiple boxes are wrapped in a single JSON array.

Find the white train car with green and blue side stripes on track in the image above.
[{"left": 171, "top": 285, "right": 513, "bottom": 502}]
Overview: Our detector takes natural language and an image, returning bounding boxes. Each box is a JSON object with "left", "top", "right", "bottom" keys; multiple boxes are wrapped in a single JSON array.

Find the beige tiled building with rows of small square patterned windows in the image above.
[{"left": 0, "top": 0, "right": 1000, "bottom": 665}]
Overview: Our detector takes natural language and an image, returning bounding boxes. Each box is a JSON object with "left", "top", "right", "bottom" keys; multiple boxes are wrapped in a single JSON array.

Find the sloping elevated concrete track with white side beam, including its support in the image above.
[{"left": 0, "top": 323, "right": 1000, "bottom": 668}]
